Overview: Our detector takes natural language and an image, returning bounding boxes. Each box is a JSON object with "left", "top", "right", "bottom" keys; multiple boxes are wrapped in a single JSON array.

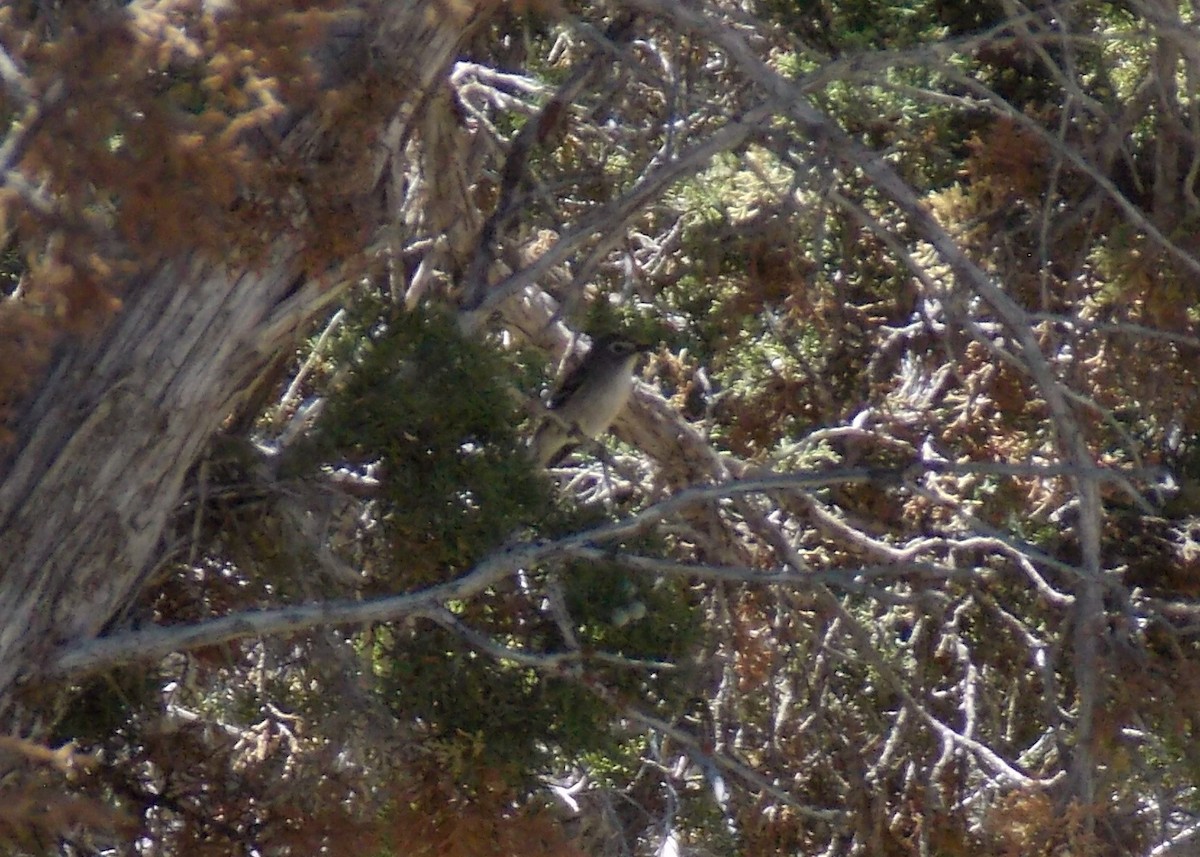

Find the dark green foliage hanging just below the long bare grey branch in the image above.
[{"left": 373, "top": 547, "right": 702, "bottom": 787}]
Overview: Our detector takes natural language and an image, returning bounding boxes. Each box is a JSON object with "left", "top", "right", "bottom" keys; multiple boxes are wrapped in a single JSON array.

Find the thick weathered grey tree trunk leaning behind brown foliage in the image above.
[{"left": 0, "top": 0, "right": 469, "bottom": 709}]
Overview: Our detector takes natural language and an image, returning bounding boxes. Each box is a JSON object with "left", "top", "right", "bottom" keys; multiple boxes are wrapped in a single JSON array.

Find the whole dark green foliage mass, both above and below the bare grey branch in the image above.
[{"left": 308, "top": 304, "right": 698, "bottom": 787}]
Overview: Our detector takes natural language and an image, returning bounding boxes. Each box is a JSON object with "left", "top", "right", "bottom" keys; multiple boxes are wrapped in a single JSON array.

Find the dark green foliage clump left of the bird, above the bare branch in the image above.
[{"left": 314, "top": 304, "right": 548, "bottom": 591}]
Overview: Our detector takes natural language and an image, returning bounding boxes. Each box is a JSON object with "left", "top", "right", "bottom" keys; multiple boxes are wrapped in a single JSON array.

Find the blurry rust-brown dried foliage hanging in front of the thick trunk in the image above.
[{"left": 0, "top": 0, "right": 396, "bottom": 442}]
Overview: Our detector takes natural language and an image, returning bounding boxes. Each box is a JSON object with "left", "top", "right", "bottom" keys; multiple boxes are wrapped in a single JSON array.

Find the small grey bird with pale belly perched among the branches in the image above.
[{"left": 530, "top": 334, "right": 647, "bottom": 467}]
